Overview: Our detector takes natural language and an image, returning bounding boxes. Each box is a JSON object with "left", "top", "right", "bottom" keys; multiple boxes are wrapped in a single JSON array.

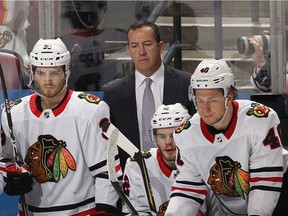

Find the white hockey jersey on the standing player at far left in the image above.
[{"left": 2, "top": 90, "right": 121, "bottom": 215}]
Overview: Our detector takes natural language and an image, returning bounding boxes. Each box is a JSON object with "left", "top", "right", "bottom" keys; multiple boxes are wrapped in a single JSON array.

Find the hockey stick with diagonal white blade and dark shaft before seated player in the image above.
[{"left": 102, "top": 121, "right": 156, "bottom": 213}]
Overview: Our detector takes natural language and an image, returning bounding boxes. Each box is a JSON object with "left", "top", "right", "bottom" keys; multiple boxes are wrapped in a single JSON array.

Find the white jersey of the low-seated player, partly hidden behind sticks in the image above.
[{"left": 122, "top": 148, "right": 216, "bottom": 216}]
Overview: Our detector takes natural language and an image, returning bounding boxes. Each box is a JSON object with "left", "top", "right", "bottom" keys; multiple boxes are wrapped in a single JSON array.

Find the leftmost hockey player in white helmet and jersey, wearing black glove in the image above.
[{"left": 0, "top": 38, "right": 121, "bottom": 215}]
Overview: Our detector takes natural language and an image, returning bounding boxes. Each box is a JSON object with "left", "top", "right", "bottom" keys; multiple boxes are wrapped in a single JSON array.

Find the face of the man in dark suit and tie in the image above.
[{"left": 127, "top": 26, "right": 164, "bottom": 76}]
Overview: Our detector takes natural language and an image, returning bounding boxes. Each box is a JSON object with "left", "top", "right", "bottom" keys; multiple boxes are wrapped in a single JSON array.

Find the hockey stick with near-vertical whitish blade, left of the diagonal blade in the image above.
[{"left": 107, "top": 127, "right": 139, "bottom": 216}]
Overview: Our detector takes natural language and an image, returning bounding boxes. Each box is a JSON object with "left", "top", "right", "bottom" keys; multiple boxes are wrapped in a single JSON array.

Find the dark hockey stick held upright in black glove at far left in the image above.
[{"left": 0, "top": 63, "right": 28, "bottom": 216}]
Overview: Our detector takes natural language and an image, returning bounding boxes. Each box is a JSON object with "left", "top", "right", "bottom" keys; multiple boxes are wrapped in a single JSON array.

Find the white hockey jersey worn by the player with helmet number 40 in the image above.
[{"left": 165, "top": 100, "right": 283, "bottom": 216}]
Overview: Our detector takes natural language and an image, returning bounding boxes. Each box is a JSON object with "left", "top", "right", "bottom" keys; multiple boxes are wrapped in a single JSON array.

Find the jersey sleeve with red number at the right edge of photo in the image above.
[{"left": 248, "top": 106, "right": 284, "bottom": 215}]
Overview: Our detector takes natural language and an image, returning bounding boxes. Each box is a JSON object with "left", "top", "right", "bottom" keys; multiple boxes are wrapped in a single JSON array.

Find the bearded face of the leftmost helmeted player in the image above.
[{"left": 34, "top": 67, "right": 66, "bottom": 98}]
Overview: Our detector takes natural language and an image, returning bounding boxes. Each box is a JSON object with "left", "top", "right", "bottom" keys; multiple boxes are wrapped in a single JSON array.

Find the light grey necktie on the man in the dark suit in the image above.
[{"left": 142, "top": 78, "right": 155, "bottom": 149}]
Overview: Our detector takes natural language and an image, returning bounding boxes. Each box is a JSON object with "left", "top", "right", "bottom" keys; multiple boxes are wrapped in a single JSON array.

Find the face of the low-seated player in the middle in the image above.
[{"left": 156, "top": 128, "right": 176, "bottom": 163}]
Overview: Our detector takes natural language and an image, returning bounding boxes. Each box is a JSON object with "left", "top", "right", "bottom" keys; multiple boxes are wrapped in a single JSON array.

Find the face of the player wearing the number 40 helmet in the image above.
[{"left": 195, "top": 89, "right": 225, "bottom": 126}]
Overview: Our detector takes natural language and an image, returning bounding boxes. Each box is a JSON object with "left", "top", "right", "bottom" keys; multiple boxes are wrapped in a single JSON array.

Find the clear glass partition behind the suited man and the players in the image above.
[{"left": 1, "top": 0, "right": 287, "bottom": 93}]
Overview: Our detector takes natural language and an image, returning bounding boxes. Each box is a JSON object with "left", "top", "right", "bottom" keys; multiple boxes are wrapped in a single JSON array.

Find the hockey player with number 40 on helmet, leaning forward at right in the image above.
[{"left": 165, "top": 59, "right": 283, "bottom": 216}]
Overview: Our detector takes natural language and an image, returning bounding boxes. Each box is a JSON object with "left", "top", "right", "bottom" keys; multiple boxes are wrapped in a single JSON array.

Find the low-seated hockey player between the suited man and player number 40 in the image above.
[{"left": 123, "top": 103, "right": 217, "bottom": 215}]
